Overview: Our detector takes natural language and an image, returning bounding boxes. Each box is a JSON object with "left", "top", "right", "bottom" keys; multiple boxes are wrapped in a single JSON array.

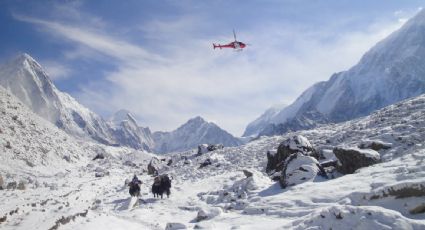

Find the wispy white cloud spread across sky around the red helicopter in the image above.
[{"left": 9, "top": 4, "right": 414, "bottom": 135}]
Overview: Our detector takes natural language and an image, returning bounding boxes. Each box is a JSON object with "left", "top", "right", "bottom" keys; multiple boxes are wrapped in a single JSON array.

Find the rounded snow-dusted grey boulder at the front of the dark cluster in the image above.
[{"left": 279, "top": 152, "right": 326, "bottom": 188}]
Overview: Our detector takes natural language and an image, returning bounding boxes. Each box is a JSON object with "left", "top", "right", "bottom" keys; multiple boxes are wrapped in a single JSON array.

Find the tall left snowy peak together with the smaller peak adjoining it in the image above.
[{"left": 0, "top": 54, "right": 153, "bottom": 150}]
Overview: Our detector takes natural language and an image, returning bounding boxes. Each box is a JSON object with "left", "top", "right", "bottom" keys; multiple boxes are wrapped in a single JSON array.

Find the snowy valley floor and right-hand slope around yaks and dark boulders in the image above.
[{"left": 0, "top": 90, "right": 425, "bottom": 230}]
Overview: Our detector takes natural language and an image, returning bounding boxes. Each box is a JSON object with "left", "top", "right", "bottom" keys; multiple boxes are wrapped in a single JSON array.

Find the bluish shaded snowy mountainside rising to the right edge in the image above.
[{"left": 244, "top": 10, "right": 425, "bottom": 136}]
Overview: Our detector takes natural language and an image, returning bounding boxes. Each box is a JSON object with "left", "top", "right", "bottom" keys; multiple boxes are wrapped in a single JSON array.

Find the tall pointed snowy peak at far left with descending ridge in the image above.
[{"left": 0, "top": 54, "right": 114, "bottom": 144}]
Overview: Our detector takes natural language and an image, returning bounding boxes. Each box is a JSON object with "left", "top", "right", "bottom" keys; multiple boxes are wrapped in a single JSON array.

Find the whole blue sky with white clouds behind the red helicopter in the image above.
[{"left": 0, "top": 0, "right": 425, "bottom": 136}]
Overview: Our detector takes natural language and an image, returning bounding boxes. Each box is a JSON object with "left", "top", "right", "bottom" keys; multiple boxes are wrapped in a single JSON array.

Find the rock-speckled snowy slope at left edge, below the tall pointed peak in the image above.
[{"left": 0, "top": 86, "right": 93, "bottom": 173}]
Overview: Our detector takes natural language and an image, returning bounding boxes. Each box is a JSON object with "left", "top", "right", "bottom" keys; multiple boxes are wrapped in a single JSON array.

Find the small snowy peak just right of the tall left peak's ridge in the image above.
[{"left": 109, "top": 110, "right": 154, "bottom": 151}]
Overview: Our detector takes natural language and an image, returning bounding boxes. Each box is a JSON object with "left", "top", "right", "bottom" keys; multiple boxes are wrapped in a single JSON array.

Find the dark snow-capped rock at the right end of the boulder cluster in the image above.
[{"left": 333, "top": 148, "right": 381, "bottom": 174}]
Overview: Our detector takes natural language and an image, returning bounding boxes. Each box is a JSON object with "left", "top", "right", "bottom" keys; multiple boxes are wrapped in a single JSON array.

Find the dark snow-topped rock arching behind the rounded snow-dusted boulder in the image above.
[{"left": 266, "top": 135, "right": 318, "bottom": 173}]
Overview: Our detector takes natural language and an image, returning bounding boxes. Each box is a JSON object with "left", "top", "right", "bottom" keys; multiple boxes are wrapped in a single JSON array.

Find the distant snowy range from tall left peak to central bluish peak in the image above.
[{"left": 0, "top": 54, "right": 242, "bottom": 153}]
